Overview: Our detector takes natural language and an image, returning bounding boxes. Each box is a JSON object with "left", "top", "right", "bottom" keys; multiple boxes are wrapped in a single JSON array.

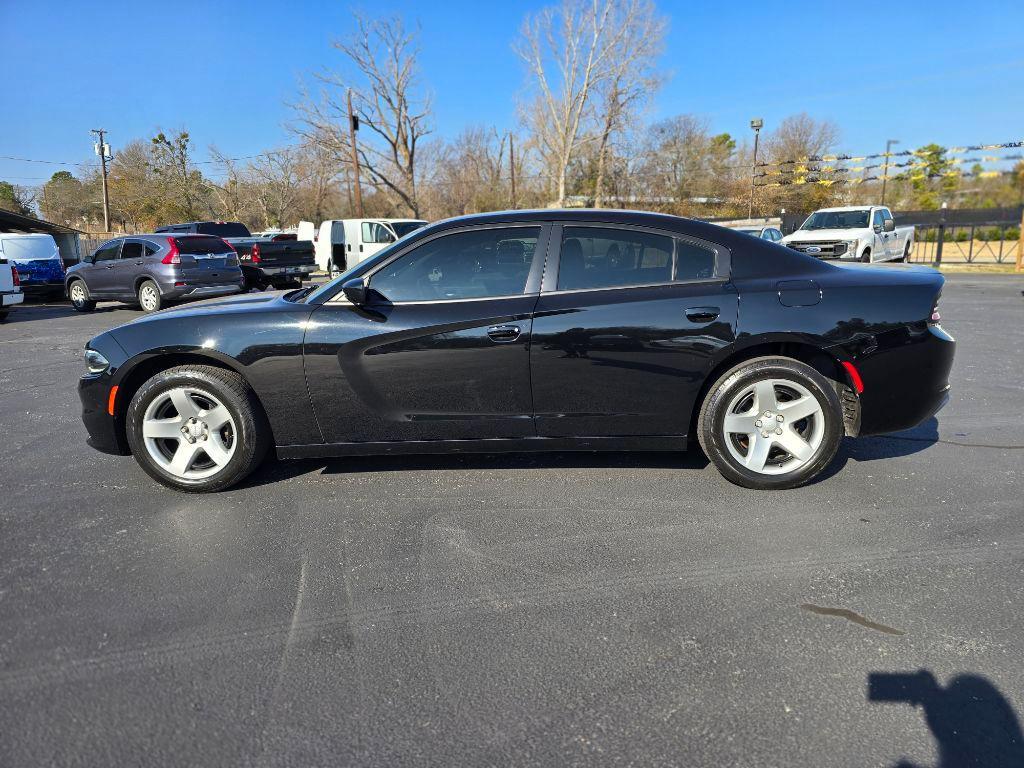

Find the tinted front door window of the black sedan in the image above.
[{"left": 370, "top": 226, "right": 541, "bottom": 302}]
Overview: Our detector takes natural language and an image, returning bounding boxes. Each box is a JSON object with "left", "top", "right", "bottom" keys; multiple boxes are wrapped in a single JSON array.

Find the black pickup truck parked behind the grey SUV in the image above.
[{"left": 157, "top": 221, "right": 316, "bottom": 291}]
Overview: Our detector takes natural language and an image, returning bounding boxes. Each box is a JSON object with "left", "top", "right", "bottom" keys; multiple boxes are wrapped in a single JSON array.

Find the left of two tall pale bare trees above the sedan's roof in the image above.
[{"left": 513, "top": 0, "right": 621, "bottom": 206}]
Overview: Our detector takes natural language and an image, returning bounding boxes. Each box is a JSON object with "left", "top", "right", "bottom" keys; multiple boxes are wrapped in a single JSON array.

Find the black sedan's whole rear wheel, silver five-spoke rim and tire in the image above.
[{"left": 697, "top": 357, "right": 844, "bottom": 489}]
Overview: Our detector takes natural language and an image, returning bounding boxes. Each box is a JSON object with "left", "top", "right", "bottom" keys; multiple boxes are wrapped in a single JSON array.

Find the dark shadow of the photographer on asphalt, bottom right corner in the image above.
[{"left": 867, "top": 670, "right": 1024, "bottom": 768}]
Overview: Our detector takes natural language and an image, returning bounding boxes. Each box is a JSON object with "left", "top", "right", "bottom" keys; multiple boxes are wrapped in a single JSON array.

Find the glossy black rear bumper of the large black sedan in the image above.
[{"left": 854, "top": 326, "right": 956, "bottom": 435}]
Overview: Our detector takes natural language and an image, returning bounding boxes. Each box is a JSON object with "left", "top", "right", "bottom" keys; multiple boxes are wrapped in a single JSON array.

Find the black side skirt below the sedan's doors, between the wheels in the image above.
[{"left": 278, "top": 435, "right": 687, "bottom": 459}]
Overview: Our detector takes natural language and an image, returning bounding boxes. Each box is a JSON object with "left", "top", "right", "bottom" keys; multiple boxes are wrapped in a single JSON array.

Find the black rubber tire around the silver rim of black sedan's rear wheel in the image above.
[{"left": 697, "top": 357, "right": 845, "bottom": 489}]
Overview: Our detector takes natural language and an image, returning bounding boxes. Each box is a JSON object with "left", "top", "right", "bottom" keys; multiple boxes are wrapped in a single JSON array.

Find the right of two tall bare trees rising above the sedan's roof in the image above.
[{"left": 594, "top": 0, "right": 668, "bottom": 208}]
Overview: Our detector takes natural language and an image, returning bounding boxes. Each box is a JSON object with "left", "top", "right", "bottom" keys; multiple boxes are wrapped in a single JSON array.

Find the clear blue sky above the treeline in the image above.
[{"left": 0, "top": 0, "right": 1024, "bottom": 185}]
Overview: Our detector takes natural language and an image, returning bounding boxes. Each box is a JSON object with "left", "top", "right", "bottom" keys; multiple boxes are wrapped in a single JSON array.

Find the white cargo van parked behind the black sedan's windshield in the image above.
[{"left": 298, "top": 219, "right": 427, "bottom": 274}]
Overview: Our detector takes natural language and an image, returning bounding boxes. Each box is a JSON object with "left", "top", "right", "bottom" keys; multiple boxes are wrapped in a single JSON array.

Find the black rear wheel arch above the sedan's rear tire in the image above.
[{"left": 687, "top": 338, "right": 860, "bottom": 441}]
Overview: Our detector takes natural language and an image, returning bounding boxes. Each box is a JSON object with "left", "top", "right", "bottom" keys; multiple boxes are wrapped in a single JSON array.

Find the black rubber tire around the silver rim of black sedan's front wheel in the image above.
[{"left": 126, "top": 365, "right": 271, "bottom": 494}]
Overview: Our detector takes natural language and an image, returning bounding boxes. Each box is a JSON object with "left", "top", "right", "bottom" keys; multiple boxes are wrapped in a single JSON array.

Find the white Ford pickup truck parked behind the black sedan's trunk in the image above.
[{"left": 782, "top": 206, "right": 913, "bottom": 262}]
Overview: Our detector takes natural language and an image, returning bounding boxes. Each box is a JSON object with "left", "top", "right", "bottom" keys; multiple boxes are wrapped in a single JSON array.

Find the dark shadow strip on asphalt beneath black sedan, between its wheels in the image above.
[{"left": 241, "top": 447, "right": 708, "bottom": 487}]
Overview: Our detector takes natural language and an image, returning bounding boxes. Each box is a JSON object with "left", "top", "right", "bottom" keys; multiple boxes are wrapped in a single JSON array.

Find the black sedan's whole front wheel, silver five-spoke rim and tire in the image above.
[{"left": 126, "top": 366, "right": 270, "bottom": 493}]
